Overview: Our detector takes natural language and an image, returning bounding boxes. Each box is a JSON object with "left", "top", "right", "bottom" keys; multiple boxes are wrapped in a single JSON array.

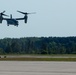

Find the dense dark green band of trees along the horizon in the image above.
[{"left": 0, "top": 37, "right": 76, "bottom": 54}]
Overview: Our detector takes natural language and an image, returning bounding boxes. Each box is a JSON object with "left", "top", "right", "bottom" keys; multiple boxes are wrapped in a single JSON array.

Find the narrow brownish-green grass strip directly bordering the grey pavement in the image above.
[{"left": 0, "top": 58, "right": 76, "bottom": 61}]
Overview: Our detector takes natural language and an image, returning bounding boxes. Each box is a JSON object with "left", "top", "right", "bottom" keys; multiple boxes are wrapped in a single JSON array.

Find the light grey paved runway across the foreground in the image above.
[{"left": 0, "top": 61, "right": 76, "bottom": 75}]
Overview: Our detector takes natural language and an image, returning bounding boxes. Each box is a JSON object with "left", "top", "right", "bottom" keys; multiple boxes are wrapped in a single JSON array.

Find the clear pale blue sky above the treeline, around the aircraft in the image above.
[{"left": 0, "top": 0, "right": 76, "bottom": 38}]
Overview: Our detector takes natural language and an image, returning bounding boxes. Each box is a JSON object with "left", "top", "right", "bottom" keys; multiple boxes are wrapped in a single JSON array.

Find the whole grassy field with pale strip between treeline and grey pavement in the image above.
[{"left": 0, "top": 54, "right": 76, "bottom": 61}]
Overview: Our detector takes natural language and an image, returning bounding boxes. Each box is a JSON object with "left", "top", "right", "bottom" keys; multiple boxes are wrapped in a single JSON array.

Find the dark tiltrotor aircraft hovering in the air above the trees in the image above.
[{"left": 0, "top": 11, "right": 35, "bottom": 26}]
